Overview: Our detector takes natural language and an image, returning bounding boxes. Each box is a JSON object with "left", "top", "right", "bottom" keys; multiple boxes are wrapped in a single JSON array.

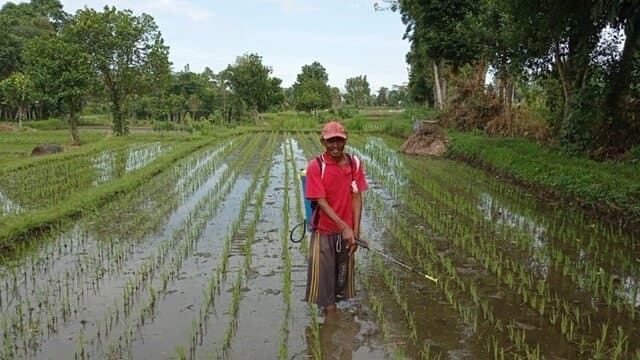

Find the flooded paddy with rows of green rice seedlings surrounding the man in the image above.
[{"left": 0, "top": 132, "right": 640, "bottom": 359}]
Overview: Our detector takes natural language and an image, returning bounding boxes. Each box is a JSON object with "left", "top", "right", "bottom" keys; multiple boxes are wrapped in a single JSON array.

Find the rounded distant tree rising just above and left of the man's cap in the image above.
[{"left": 292, "top": 61, "right": 331, "bottom": 113}]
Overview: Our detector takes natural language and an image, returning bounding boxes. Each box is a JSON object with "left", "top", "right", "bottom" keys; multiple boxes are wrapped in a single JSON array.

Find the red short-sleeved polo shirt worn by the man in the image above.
[{"left": 305, "top": 153, "right": 368, "bottom": 234}]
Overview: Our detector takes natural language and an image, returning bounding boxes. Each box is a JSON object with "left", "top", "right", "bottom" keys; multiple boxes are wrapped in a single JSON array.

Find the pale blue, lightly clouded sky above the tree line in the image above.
[{"left": 0, "top": 0, "right": 409, "bottom": 93}]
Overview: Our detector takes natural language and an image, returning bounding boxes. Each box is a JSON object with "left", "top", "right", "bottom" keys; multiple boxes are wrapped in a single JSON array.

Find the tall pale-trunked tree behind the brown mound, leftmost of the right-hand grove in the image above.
[{"left": 396, "top": 0, "right": 495, "bottom": 108}]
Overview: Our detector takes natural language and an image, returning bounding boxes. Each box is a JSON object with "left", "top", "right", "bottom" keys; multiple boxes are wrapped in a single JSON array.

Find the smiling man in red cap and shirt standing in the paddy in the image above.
[{"left": 305, "top": 121, "right": 368, "bottom": 315}]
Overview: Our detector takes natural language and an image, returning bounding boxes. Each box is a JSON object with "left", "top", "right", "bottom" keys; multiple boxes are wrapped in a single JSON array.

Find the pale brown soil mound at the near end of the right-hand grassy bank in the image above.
[{"left": 400, "top": 121, "right": 449, "bottom": 156}]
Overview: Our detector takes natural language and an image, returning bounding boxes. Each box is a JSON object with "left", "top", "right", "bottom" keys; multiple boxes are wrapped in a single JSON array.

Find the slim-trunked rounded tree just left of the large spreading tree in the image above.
[{"left": 23, "top": 37, "right": 94, "bottom": 145}]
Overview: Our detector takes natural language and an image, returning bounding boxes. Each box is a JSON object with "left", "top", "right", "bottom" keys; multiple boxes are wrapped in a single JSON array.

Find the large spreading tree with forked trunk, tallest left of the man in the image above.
[{"left": 65, "top": 7, "right": 169, "bottom": 135}]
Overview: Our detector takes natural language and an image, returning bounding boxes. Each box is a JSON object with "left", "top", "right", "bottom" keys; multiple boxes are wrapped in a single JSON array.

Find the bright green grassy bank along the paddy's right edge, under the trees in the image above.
[{"left": 448, "top": 131, "right": 640, "bottom": 221}]
